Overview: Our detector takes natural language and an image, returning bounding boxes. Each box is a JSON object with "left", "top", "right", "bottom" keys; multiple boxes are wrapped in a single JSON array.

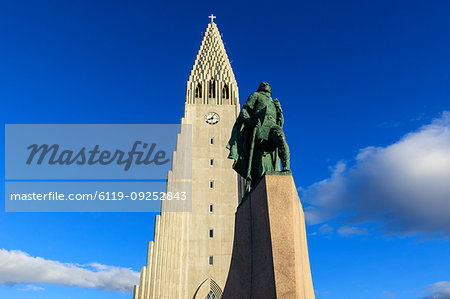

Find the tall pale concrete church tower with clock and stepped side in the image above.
[{"left": 133, "top": 16, "right": 240, "bottom": 299}]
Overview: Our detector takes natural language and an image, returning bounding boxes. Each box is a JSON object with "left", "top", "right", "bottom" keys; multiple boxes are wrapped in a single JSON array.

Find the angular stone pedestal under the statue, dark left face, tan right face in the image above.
[{"left": 222, "top": 173, "right": 314, "bottom": 299}]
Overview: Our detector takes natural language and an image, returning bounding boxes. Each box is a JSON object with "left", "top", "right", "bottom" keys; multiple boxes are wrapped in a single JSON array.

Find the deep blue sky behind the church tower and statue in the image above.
[{"left": 0, "top": 1, "right": 450, "bottom": 299}]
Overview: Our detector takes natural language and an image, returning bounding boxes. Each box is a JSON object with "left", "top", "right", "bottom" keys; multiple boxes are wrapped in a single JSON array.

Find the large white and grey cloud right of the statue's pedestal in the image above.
[{"left": 303, "top": 111, "right": 450, "bottom": 237}]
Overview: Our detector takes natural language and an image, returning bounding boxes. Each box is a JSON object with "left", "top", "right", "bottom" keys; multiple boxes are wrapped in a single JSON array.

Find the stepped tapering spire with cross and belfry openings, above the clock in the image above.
[{"left": 186, "top": 15, "right": 238, "bottom": 104}]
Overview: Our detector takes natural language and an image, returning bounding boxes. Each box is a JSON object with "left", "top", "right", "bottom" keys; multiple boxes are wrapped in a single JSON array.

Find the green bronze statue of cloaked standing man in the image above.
[{"left": 227, "top": 82, "right": 290, "bottom": 192}]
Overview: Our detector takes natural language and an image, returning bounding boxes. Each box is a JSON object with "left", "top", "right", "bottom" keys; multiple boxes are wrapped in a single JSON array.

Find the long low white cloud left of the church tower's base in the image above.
[{"left": 0, "top": 249, "right": 139, "bottom": 292}]
